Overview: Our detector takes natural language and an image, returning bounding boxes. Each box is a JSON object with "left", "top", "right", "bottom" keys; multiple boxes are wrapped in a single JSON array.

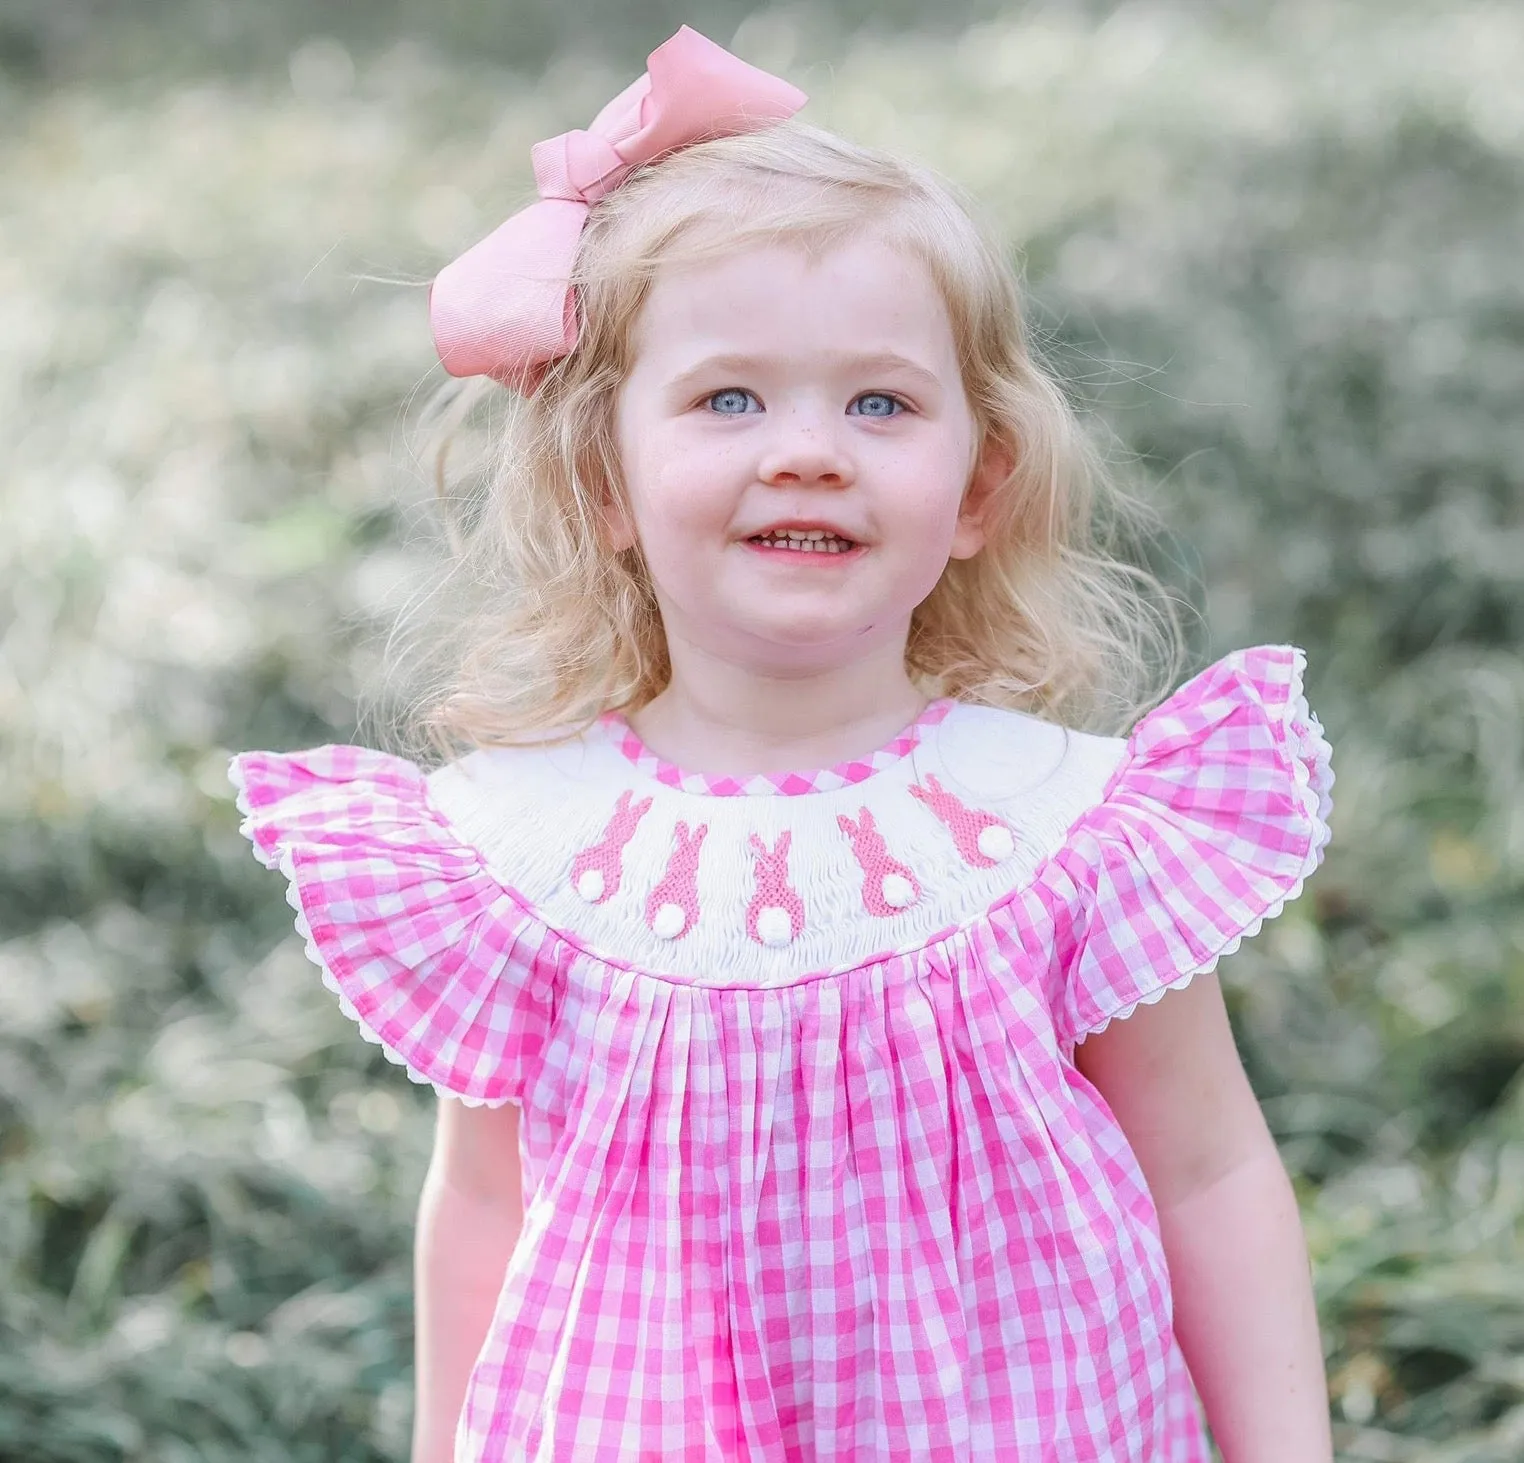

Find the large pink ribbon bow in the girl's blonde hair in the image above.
[{"left": 428, "top": 26, "right": 806, "bottom": 396}]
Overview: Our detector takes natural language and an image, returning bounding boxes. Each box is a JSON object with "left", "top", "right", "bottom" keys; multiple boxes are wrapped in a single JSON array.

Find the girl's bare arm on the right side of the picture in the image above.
[{"left": 1074, "top": 975, "right": 1334, "bottom": 1463}]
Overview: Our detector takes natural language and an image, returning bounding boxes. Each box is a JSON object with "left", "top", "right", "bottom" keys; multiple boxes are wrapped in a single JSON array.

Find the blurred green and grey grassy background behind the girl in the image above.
[{"left": 0, "top": 0, "right": 1524, "bottom": 1463}]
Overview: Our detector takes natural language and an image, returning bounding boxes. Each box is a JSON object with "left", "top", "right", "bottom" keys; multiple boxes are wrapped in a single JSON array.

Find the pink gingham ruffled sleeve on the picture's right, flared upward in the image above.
[{"left": 1039, "top": 646, "right": 1334, "bottom": 1045}]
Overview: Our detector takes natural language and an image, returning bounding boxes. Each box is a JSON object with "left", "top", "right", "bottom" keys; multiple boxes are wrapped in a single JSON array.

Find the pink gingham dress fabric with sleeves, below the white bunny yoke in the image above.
[{"left": 233, "top": 648, "right": 1330, "bottom": 1463}]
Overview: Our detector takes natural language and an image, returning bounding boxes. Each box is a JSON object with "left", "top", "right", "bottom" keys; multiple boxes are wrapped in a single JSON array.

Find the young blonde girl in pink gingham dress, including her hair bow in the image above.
[{"left": 233, "top": 29, "right": 1332, "bottom": 1463}]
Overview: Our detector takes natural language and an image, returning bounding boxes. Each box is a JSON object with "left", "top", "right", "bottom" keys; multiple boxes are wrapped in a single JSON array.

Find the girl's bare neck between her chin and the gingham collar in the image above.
[{"left": 628, "top": 646, "right": 927, "bottom": 777}]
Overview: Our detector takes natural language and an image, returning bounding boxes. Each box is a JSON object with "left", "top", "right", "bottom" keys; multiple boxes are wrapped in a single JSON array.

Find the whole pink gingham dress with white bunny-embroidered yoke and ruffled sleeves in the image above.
[{"left": 232, "top": 646, "right": 1332, "bottom": 1463}]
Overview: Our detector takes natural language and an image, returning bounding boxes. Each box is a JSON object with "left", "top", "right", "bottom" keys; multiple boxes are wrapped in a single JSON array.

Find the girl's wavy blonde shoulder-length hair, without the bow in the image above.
[{"left": 377, "top": 122, "right": 1180, "bottom": 756}]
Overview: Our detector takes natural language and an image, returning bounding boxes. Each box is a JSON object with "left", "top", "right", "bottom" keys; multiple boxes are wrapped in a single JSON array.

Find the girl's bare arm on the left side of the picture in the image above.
[{"left": 413, "top": 1097, "right": 524, "bottom": 1463}]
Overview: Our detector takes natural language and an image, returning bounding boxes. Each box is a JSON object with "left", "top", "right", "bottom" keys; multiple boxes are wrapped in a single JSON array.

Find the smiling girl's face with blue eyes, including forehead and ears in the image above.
[{"left": 610, "top": 238, "right": 1003, "bottom": 674}]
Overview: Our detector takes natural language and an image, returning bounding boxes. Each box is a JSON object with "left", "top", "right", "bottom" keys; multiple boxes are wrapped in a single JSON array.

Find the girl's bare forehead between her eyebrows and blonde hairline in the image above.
[{"left": 634, "top": 236, "right": 956, "bottom": 357}]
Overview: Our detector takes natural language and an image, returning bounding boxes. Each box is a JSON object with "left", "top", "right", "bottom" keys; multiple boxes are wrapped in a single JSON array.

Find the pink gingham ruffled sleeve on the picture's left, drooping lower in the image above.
[{"left": 229, "top": 747, "right": 555, "bottom": 1106}]
